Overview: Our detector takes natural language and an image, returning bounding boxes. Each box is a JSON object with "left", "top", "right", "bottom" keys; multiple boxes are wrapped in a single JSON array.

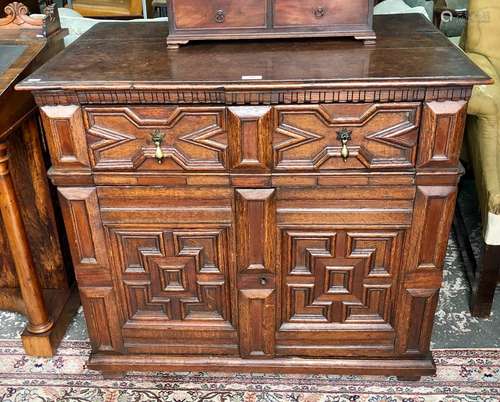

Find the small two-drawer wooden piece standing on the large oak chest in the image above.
[{"left": 167, "top": 0, "right": 375, "bottom": 49}]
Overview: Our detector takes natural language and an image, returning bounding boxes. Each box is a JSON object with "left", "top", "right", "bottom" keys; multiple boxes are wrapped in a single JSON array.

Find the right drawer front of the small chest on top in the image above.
[{"left": 273, "top": 0, "right": 369, "bottom": 28}]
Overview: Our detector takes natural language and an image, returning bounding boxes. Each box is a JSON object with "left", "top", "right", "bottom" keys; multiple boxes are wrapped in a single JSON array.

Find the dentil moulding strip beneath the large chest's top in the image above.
[{"left": 34, "top": 87, "right": 472, "bottom": 105}]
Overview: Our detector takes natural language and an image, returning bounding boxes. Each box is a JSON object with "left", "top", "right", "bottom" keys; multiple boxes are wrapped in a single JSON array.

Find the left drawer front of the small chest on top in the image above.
[{"left": 173, "top": 0, "right": 267, "bottom": 29}]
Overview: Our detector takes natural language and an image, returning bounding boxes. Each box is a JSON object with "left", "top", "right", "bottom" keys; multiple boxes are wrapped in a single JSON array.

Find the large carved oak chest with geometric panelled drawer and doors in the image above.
[{"left": 18, "top": 15, "right": 489, "bottom": 378}]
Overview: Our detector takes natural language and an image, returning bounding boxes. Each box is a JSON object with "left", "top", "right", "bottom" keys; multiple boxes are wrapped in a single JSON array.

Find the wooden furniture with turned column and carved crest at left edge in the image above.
[{"left": 0, "top": 3, "right": 79, "bottom": 356}]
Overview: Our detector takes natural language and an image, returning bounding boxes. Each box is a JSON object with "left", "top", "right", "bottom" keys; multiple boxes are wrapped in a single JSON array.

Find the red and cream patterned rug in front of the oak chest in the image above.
[{"left": 0, "top": 341, "right": 500, "bottom": 402}]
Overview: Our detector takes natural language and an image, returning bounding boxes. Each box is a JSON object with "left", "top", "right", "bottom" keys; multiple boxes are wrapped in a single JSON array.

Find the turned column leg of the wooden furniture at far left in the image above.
[{"left": 0, "top": 142, "right": 54, "bottom": 334}]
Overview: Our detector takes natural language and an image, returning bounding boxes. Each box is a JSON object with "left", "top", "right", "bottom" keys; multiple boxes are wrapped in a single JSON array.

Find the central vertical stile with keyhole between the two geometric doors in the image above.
[{"left": 236, "top": 188, "right": 276, "bottom": 358}]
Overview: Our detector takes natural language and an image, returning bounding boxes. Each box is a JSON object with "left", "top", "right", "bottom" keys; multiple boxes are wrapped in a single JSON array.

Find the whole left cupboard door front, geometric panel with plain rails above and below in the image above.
[{"left": 98, "top": 186, "right": 238, "bottom": 355}]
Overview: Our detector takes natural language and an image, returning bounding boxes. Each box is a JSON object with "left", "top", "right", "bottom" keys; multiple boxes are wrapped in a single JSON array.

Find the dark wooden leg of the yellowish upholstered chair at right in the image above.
[{"left": 471, "top": 245, "right": 500, "bottom": 318}]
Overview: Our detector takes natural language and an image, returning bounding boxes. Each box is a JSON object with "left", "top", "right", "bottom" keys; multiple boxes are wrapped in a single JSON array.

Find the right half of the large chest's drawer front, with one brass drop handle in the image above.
[{"left": 272, "top": 103, "right": 420, "bottom": 171}]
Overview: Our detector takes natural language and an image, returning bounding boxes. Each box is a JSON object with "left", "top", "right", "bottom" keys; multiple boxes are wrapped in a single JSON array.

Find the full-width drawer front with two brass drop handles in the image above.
[{"left": 84, "top": 103, "right": 420, "bottom": 172}]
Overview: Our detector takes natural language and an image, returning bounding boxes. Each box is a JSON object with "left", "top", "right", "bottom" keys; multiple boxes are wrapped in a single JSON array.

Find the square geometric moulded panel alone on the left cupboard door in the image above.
[{"left": 106, "top": 225, "right": 230, "bottom": 325}]
